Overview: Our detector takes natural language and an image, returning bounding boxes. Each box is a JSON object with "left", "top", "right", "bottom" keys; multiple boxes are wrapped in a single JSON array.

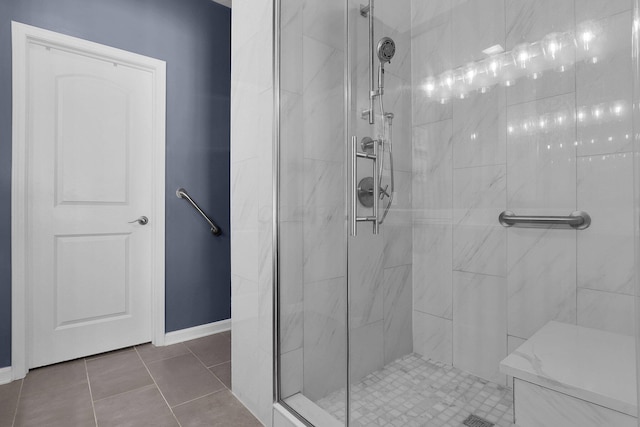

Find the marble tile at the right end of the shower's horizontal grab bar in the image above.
[{"left": 577, "top": 153, "right": 635, "bottom": 295}]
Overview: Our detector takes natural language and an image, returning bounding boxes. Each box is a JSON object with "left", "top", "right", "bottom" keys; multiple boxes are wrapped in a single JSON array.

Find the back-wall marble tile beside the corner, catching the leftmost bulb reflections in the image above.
[{"left": 411, "top": 22, "right": 453, "bottom": 126}]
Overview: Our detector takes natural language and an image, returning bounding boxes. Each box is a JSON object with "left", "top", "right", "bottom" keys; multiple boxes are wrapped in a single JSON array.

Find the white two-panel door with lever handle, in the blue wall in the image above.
[{"left": 26, "top": 31, "right": 157, "bottom": 368}]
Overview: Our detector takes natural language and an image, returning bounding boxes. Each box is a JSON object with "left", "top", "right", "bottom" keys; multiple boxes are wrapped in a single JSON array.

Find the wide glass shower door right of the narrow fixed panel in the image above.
[{"left": 348, "top": 0, "right": 636, "bottom": 425}]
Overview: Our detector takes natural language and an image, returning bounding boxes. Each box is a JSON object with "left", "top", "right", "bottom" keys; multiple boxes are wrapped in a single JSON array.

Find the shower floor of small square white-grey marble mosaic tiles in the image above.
[{"left": 316, "top": 354, "right": 513, "bottom": 427}]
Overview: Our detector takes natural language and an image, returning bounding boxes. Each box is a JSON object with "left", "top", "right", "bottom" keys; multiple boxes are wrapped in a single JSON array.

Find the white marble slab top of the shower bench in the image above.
[{"left": 500, "top": 322, "right": 638, "bottom": 417}]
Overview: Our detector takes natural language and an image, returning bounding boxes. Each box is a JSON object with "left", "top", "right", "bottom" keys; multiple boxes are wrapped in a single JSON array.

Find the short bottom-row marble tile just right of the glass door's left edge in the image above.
[{"left": 349, "top": 320, "right": 384, "bottom": 384}]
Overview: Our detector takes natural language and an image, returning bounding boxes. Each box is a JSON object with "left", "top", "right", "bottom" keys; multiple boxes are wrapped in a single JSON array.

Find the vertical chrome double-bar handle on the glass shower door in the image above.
[{"left": 351, "top": 136, "right": 380, "bottom": 237}]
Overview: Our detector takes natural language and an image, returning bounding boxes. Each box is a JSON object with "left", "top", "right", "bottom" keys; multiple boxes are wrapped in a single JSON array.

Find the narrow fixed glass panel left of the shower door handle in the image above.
[{"left": 276, "top": 0, "right": 347, "bottom": 425}]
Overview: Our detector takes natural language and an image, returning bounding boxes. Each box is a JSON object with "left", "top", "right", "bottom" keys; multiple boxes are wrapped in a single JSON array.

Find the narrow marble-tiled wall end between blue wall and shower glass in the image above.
[{"left": 231, "top": 0, "right": 274, "bottom": 426}]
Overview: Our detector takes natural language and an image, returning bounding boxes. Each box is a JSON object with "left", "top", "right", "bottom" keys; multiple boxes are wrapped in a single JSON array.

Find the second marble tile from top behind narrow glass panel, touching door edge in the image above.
[{"left": 302, "top": 37, "right": 345, "bottom": 162}]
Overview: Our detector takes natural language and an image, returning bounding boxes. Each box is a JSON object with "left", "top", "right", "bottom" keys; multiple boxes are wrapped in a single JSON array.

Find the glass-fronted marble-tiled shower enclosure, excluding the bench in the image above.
[{"left": 276, "top": 0, "right": 640, "bottom": 426}]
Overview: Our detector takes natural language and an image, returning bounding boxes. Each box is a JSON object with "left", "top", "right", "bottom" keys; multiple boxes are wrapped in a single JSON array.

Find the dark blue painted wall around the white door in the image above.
[{"left": 0, "top": 0, "right": 231, "bottom": 367}]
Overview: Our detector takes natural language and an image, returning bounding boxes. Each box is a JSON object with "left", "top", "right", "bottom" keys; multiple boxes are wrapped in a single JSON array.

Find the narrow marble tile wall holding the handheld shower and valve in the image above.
[{"left": 348, "top": 0, "right": 413, "bottom": 384}]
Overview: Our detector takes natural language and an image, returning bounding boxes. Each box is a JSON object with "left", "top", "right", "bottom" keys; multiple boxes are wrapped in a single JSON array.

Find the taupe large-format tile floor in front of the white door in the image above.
[{"left": 0, "top": 332, "right": 262, "bottom": 427}]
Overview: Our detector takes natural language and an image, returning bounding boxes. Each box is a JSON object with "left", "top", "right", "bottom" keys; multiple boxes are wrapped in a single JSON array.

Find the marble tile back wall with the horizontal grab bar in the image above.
[{"left": 411, "top": 0, "right": 635, "bottom": 382}]
